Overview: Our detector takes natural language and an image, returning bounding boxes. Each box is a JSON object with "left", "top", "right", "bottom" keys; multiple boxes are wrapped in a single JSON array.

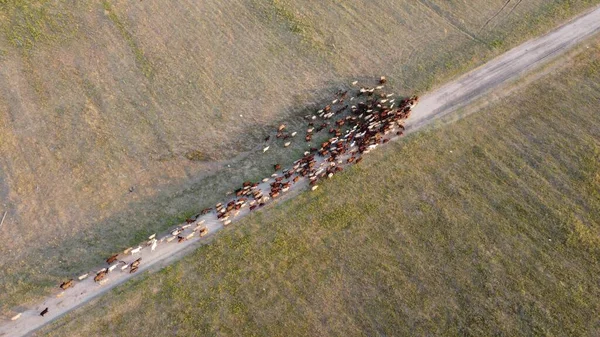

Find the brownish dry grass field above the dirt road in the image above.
[{"left": 0, "top": 0, "right": 599, "bottom": 314}]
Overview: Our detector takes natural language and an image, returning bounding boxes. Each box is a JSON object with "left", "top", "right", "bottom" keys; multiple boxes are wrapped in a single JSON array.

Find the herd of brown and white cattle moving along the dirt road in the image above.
[{"left": 27, "top": 77, "right": 418, "bottom": 316}]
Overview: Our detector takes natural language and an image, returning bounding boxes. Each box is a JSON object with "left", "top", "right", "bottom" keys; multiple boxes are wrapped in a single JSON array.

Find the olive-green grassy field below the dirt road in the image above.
[{"left": 39, "top": 38, "right": 600, "bottom": 336}]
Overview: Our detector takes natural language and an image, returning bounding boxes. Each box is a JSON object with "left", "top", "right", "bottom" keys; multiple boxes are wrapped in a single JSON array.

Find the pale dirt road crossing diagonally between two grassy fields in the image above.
[{"left": 0, "top": 4, "right": 600, "bottom": 337}]
